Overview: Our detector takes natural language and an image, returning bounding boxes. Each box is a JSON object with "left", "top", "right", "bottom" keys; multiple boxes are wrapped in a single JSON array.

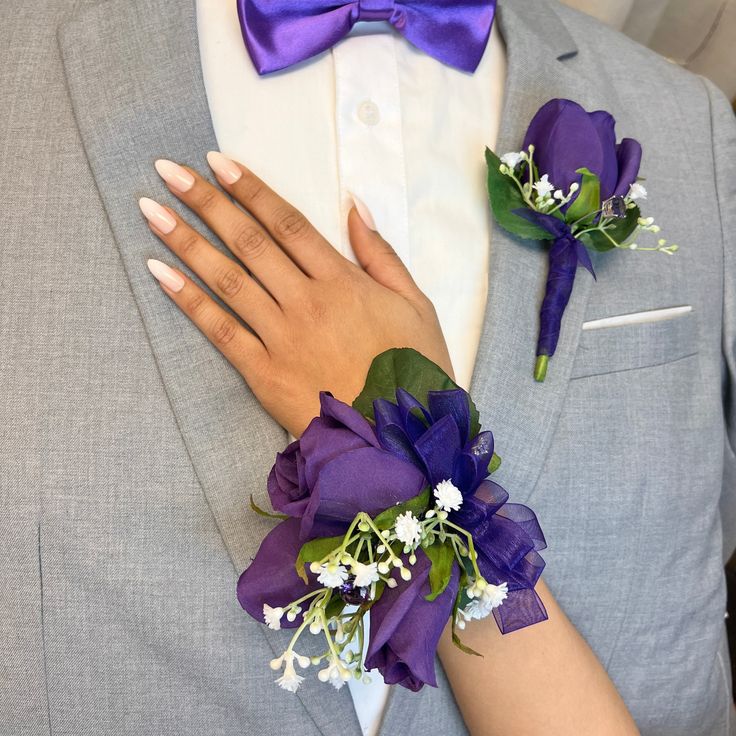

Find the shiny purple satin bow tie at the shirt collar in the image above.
[{"left": 237, "top": 0, "right": 496, "bottom": 74}]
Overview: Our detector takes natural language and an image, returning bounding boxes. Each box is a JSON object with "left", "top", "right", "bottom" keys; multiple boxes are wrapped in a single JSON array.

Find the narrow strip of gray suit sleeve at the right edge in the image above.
[{"left": 705, "top": 80, "right": 736, "bottom": 559}]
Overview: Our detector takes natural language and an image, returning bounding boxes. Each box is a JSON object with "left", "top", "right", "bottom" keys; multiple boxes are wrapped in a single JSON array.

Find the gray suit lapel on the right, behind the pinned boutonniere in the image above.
[{"left": 472, "top": 0, "right": 602, "bottom": 502}]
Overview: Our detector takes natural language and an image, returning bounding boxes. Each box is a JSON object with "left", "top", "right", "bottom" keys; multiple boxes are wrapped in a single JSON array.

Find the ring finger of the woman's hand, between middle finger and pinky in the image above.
[{"left": 139, "top": 197, "right": 283, "bottom": 337}]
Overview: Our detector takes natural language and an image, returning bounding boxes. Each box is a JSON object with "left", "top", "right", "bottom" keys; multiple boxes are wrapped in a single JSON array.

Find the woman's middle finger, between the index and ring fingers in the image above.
[{"left": 156, "top": 159, "right": 306, "bottom": 303}]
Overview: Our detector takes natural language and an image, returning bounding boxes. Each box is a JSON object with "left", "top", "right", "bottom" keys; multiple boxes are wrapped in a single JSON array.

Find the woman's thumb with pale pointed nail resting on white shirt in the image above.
[{"left": 348, "top": 194, "right": 420, "bottom": 301}]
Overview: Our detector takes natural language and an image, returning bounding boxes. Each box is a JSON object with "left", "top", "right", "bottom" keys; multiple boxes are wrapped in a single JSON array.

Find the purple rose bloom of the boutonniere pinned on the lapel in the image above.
[{"left": 523, "top": 99, "right": 641, "bottom": 201}]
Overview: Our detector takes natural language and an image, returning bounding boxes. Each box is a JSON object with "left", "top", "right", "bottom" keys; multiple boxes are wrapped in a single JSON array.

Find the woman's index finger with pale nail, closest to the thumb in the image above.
[{"left": 207, "top": 151, "right": 347, "bottom": 278}]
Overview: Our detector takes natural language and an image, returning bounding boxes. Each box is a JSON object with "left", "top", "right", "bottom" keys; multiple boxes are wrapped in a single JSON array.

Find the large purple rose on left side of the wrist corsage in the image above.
[{"left": 238, "top": 393, "right": 427, "bottom": 626}]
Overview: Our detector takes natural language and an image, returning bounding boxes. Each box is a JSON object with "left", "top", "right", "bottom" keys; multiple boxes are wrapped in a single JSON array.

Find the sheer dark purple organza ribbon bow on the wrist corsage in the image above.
[{"left": 373, "top": 386, "right": 548, "bottom": 634}]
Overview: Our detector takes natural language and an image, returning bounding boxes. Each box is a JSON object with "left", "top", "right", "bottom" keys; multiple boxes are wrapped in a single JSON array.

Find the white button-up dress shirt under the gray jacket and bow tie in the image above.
[{"left": 197, "top": 0, "right": 506, "bottom": 735}]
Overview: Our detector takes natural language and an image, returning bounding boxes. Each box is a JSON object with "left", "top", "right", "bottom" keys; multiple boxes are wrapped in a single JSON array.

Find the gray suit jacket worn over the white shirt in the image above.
[{"left": 0, "top": 0, "right": 736, "bottom": 736}]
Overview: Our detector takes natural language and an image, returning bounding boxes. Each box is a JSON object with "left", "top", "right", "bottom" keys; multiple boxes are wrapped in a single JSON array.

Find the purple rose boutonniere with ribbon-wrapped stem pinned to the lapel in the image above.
[{"left": 486, "top": 99, "right": 678, "bottom": 381}]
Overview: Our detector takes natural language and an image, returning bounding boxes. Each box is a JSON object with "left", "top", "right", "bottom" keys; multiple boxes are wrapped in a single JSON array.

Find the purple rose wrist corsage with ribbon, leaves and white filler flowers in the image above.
[{"left": 238, "top": 349, "right": 547, "bottom": 692}]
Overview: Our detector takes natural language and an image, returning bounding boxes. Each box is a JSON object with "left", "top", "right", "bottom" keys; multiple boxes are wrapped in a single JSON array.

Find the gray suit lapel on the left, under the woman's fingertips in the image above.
[{"left": 55, "top": 0, "right": 286, "bottom": 572}]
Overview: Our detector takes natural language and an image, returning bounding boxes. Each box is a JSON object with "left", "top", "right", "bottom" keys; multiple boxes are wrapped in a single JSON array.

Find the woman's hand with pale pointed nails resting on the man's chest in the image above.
[{"left": 140, "top": 152, "right": 452, "bottom": 437}]
